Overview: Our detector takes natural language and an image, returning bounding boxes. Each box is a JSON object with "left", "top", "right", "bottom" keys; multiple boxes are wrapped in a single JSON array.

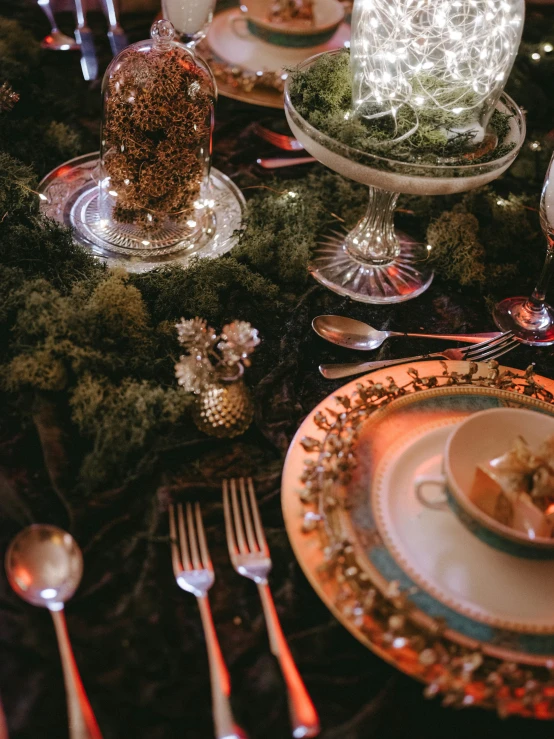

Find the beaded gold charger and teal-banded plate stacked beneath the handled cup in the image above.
[{"left": 282, "top": 362, "right": 554, "bottom": 718}]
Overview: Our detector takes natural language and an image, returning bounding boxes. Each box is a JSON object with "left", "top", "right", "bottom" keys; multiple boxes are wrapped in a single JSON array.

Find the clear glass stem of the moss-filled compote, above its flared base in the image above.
[{"left": 346, "top": 187, "right": 400, "bottom": 265}]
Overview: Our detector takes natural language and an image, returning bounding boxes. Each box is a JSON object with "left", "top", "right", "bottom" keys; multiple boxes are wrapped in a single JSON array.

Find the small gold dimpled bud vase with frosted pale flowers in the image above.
[{"left": 175, "top": 318, "right": 260, "bottom": 438}]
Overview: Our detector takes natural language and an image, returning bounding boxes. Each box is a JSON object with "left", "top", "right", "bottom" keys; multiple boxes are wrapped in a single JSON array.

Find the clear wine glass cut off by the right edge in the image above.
[{"left": 493, "top": 156, "right": 554, "bottom": 346}]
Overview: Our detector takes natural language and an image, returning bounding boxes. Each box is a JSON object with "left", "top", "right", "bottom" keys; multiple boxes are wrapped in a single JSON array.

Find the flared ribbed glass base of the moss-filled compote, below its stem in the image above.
[{"left": 310, "top": 232, "right": 433, "bottom": 304}]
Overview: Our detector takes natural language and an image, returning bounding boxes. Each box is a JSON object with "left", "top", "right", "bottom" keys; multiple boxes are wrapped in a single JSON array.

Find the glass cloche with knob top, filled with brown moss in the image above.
[{"left": 96, "top": 20, "right": 216, "bottom": 257}]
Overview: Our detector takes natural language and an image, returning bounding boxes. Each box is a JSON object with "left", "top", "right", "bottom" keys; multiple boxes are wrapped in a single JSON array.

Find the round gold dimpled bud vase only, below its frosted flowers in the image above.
[{"left": 192, "top": 378, "right": 254, "bottom": 439}]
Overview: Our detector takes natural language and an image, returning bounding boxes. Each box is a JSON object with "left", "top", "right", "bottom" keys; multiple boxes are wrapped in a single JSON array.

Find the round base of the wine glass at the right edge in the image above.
[{"left": 493, "top": 298, "right": 554, "bottom": 346}]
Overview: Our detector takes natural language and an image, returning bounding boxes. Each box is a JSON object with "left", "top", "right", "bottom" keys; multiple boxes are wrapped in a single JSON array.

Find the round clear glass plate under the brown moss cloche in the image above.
[{"left": 38, "top": 152, "right": 245, "bottom": 272}]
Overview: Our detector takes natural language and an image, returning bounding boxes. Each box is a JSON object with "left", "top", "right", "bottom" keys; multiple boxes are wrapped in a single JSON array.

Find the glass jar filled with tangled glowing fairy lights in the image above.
[{"left": 350, "top": 0, "right": 525, "bottom": 143}]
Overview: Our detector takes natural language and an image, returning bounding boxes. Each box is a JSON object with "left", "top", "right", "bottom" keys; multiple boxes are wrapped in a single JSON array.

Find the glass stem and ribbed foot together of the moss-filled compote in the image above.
[{"left": 310, "top": 187, "right": 433, "bottom": 303}]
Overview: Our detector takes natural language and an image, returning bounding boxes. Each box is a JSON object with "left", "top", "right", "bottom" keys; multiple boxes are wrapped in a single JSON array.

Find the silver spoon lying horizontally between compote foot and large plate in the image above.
[{"left": 312, "top": 316, "right": 500, "bottom": 352}]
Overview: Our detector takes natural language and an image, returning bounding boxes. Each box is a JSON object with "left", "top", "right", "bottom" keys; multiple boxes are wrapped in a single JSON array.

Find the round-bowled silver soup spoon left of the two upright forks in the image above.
[{"left": 6, "top": 524, "right": 102, "bottom": 739}]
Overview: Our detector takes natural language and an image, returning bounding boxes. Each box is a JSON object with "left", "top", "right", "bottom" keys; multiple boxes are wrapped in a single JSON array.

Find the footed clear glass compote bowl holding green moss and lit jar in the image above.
[{"left": 285, "top": 51, "right": 525, "bottom": 303}]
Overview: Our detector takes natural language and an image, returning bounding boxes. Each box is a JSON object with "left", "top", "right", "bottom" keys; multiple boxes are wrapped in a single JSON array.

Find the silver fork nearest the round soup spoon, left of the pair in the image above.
[{"left": 169, "top": 503, "right": 248, "bottom": 739}]
